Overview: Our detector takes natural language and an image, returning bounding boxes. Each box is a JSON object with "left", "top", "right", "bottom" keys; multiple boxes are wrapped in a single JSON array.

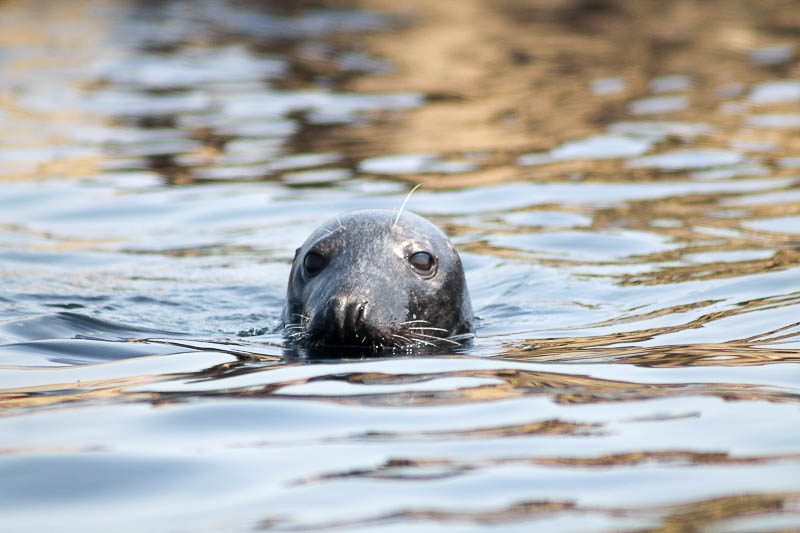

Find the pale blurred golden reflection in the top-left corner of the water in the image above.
[{"left": 0, "top": 0, "right": 108, "bottom": 180}]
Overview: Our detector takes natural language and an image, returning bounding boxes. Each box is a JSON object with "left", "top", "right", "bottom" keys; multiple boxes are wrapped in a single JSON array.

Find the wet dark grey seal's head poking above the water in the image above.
[{"left": 281, "top": 209, "right": 474, "bottom": 353}]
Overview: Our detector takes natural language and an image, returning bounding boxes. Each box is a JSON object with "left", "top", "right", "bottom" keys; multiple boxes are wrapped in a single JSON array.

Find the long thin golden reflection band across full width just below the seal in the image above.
[{"left": 0, "top": 353, "right": 800, "bottom": 418}]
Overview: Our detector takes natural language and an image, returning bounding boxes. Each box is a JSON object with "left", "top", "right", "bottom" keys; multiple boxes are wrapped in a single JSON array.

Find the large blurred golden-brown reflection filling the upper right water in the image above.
[{"left": 347, "top": 0, "right": 800, "bottom": 189}]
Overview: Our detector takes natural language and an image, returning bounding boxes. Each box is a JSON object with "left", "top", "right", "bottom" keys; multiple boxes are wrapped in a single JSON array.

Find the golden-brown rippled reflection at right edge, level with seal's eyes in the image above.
[{"left": 460, "top": 188, "right": 800, "bottom": 286}]
